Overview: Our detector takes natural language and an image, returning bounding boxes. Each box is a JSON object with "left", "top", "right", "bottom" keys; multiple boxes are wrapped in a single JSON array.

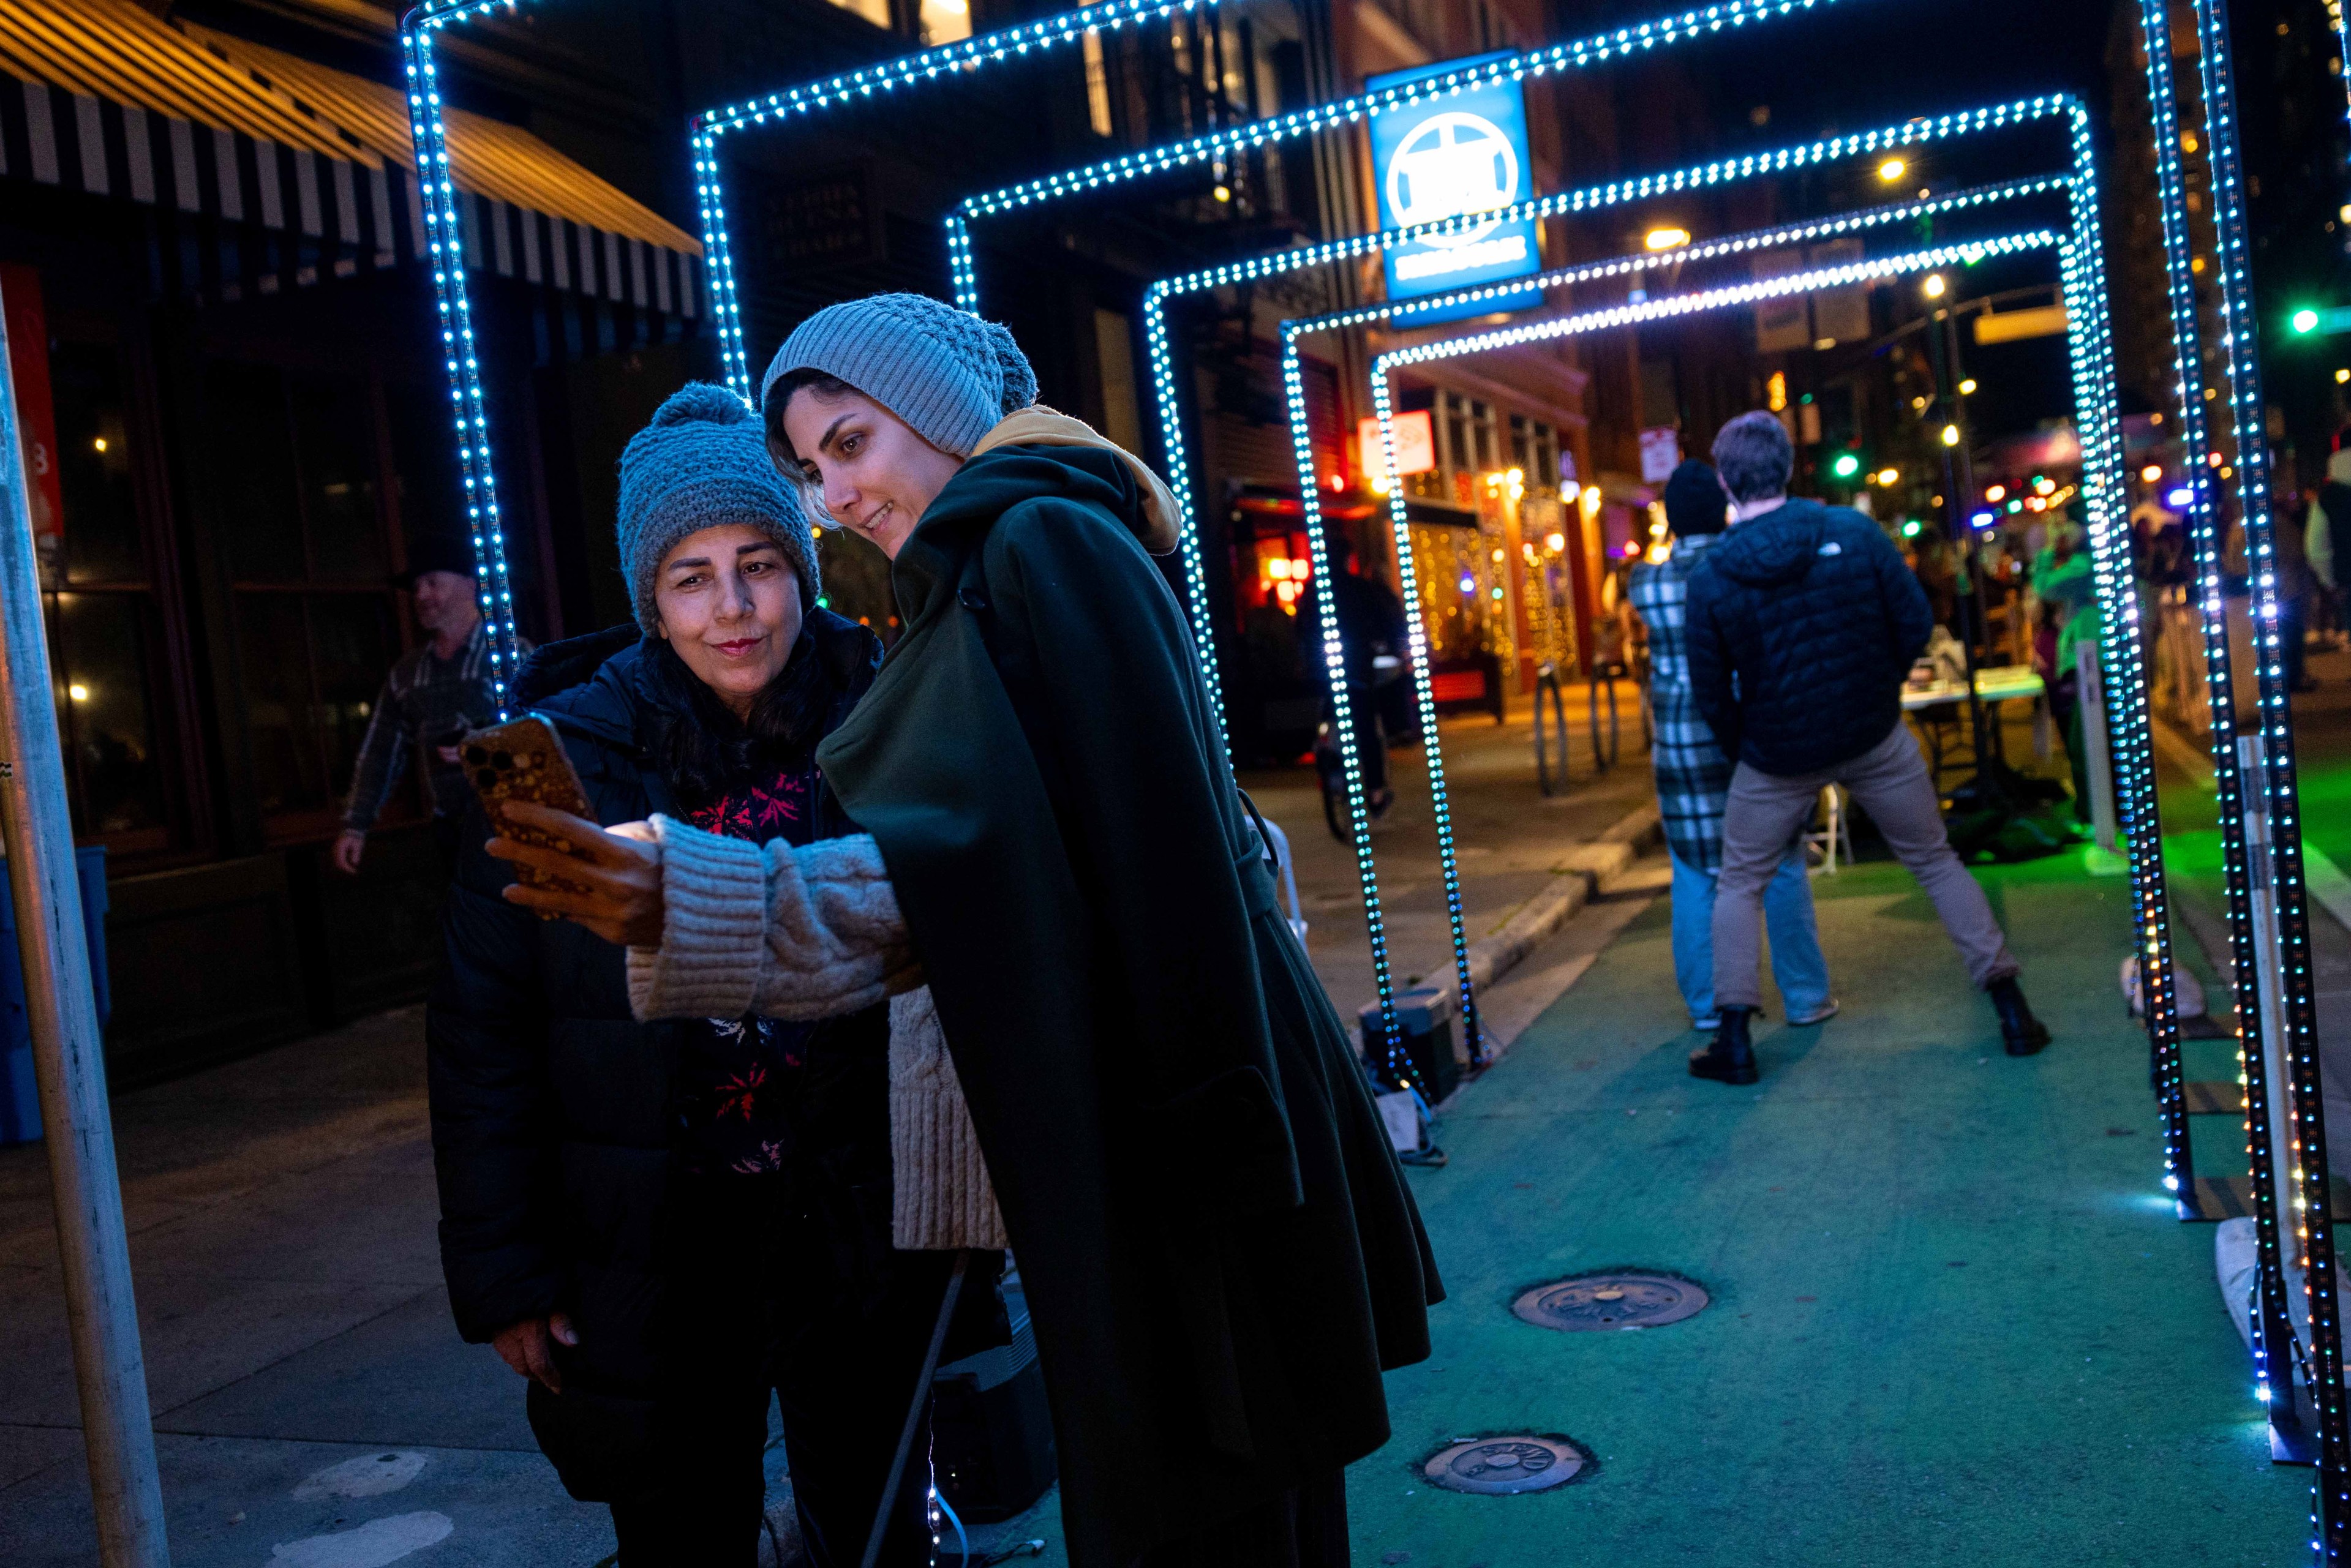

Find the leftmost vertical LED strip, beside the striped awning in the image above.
[{"left": 400, "top": 20, "right": 517, "bottom": 719}]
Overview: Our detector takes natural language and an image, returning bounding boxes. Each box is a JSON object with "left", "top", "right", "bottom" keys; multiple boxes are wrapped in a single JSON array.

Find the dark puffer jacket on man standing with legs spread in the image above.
[{"left": 1690, "top": 501, "right": 1935, "bottom": 776}]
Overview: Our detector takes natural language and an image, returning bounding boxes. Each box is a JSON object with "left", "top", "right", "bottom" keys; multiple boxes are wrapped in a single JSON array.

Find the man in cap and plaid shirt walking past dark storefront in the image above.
[{"left": 334, "top": 538, "right": 529, "bottom": 877}]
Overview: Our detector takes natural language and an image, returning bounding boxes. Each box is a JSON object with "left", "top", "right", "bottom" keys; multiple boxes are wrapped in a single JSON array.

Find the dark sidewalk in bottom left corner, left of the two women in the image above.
[{"left": 0, "top": 1006, "right": 611, "bottom": 1568}]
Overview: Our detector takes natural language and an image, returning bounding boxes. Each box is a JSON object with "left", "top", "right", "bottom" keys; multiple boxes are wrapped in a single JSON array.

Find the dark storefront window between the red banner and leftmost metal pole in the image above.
[{"left": 42, "top": 343, "right": 169, "bottom": 853}]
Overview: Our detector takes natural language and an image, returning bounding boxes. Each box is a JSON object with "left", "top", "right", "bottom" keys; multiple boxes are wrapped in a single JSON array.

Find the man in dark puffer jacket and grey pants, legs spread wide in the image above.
[{"left": 1688, "top": 414, "right": 2050, "bottom": 1084}]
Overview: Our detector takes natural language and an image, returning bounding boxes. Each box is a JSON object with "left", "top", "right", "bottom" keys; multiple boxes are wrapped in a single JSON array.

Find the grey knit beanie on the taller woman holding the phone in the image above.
[{"left": 759, "top": 294, "right": 1037, "bottom": 459}]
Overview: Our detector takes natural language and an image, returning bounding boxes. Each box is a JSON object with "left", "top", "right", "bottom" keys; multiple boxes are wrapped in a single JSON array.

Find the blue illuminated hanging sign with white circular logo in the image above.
[{"left": 1364, "top": 56, "right": 1542, "bottom": 320}]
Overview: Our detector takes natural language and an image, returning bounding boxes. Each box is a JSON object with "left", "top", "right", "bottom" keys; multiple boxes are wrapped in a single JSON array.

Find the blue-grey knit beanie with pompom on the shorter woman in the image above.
[{"left": 616, "top": 381, "right": 818, "bottom": 632}]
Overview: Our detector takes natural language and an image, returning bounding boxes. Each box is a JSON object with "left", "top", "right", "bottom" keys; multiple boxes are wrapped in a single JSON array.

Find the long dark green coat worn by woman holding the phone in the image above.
[{"left": 818, "top": 447, "right": 1441, "bottom": 1568}]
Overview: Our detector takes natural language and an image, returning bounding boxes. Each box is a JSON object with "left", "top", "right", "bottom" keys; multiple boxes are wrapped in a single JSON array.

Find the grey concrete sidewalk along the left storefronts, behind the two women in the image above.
[{"left": 0, "top": 691, "right": 1648, "bottom": 1568}]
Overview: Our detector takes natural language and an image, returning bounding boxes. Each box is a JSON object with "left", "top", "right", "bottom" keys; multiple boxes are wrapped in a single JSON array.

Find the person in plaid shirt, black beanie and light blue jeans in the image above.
[{"left": 1629, "top": 459, "right": 1836, "bottom": 1030}]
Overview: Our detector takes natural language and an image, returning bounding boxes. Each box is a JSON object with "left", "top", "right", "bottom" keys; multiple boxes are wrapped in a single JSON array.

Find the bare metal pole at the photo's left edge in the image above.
[{"left": 0, "top": 278, "right": 171, "bottom": 1568}]
